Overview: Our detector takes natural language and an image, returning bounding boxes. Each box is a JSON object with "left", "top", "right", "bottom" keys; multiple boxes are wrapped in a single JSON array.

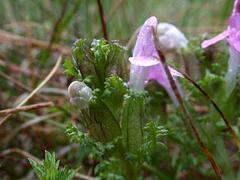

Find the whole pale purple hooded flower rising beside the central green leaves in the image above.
[{"left": 129, "top": 17, "right": 181, "bottom": 104}]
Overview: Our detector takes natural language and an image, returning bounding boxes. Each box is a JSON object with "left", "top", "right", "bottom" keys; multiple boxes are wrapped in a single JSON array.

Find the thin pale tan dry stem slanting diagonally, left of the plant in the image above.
[{"left": 0, "top": 55, "right": 62, "bottom": 126}]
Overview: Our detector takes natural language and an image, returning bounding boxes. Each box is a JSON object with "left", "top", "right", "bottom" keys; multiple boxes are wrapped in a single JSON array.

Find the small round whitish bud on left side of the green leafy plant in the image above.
[{"left": 68, "top": 81, "right": 92, "bottom": 109}]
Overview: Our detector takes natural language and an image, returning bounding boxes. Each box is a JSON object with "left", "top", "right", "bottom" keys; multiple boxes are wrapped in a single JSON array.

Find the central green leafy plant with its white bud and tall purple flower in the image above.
[{"left": 62, "top": 17, "right": 184, "bottom": 179}]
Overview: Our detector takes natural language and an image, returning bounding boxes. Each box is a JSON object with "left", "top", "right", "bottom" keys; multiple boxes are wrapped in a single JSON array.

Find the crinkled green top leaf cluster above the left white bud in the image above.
[{"left": 73, "top": 39, "right": 127, "bottom": 90}]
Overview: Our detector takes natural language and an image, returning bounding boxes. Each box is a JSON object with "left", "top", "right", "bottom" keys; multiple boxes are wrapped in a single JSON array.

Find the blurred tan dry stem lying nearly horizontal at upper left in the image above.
[{"left": 0, "top": 30, "right": 71, "bottom": 55}]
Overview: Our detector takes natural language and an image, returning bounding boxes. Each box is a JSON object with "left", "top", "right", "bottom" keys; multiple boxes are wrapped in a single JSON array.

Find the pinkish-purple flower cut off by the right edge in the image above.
[{"left": 202, "top": 0, "right": 240, "bottom": 95}]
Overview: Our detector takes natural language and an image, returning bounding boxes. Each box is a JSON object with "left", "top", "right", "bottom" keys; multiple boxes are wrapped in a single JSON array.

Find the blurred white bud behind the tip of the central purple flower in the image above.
[{"left": 157, "top": 23, "right": 188, "bottom": 51}]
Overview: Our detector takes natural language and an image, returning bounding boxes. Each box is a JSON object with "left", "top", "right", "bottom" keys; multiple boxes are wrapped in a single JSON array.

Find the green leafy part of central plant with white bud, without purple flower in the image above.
[{"left": 63, "top": 39, "right": 146, "bottom": 179}]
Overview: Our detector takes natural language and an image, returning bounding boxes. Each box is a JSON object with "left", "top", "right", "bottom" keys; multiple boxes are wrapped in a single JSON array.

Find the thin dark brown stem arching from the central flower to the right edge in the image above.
[{"left": 171, "top": 68, "right": 240, "bottom": 150}]
